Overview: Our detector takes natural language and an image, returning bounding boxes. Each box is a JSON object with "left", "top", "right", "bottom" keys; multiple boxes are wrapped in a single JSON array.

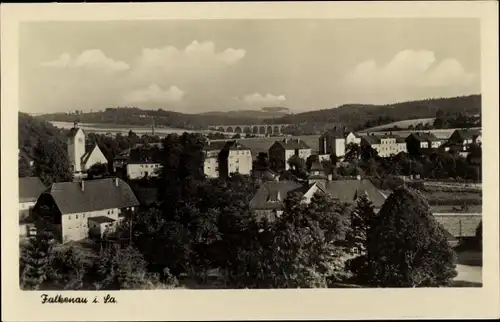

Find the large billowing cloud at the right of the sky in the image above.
[{"left": 345, "top": 50, "right": 475, "bottom": 89}]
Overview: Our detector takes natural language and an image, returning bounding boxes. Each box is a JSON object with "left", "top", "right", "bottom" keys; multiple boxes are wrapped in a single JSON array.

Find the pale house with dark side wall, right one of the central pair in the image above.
[{"left": 219, "top": 141, "right": 253, "bottom": 177}]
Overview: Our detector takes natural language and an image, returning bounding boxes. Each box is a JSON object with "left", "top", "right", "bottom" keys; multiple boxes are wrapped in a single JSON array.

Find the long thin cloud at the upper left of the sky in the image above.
[{"left": 41, "top": 49, "right": 130, "bottom": 71}]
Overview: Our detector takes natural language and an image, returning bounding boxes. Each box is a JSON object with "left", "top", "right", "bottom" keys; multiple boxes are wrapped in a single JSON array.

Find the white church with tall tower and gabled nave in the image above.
[{"left": 67, "top": 122, "right": 108, "bottom": 176}]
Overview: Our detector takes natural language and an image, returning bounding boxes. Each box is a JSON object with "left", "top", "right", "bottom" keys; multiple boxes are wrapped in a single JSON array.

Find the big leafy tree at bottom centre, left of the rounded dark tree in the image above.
[{"left": 234, "top": 195, "right": 343, "bottom": 288}]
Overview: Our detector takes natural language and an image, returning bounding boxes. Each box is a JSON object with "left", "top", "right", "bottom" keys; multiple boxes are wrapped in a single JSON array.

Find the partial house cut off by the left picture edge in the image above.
[{"left": 19, "top": 177, "right": 47, "bottom": 237}]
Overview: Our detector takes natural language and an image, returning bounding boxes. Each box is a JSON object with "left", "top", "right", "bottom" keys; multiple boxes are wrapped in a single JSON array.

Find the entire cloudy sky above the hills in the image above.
[{"left": 19, "top": 18, "right": 480, "bottom": 113}]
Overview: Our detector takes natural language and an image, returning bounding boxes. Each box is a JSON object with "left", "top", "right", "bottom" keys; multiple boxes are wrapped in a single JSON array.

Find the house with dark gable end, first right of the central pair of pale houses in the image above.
[{"left": 269, "top": 138, "right": 312, "bottom": 172}]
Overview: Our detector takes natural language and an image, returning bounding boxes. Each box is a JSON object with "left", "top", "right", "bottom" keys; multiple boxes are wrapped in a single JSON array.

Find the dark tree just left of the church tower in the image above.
[{"left": 34, "top": 139, "right": 73, "bottom": 186}]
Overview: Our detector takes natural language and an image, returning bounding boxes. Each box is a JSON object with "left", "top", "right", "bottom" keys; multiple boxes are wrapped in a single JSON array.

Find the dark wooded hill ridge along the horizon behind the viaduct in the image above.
[{"left": 35, "top": 95, "right": 481, "bottom": 130}]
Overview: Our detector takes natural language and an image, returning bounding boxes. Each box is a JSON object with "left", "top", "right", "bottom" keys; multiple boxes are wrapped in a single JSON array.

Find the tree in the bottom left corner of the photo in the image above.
[{"left": 19, "top": 232, "right": 54, "bottom": 290}]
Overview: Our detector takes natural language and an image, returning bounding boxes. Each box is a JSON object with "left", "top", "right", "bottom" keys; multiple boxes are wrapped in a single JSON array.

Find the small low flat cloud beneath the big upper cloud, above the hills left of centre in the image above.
[{"left": 123, "top": 84, "right": 185, "bottom": 104}]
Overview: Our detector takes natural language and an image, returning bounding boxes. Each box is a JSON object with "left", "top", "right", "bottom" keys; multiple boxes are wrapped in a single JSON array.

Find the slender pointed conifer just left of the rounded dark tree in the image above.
[{"left": 346, "top": 194, "right": 375, "bottom": 254}]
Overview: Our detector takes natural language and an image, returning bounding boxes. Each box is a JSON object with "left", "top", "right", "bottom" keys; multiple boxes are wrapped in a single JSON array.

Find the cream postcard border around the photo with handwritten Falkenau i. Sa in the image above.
[{"left": 0, "top": 1, "right": 500, "bottom": 321}]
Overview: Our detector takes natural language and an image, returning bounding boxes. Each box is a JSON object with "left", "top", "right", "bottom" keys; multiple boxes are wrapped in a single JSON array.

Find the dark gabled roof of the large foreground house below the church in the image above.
[{"left": 44, "top": 178, "right": 139, "bottom": 214}]
